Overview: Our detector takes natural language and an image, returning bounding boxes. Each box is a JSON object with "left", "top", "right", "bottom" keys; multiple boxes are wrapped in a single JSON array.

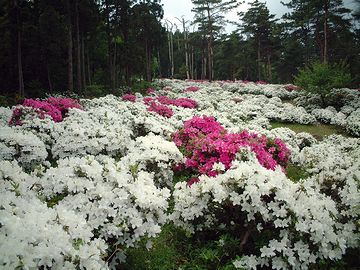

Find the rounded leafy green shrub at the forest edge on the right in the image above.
[{"left": 294, "top": 61, "right": 351, "bottom": 106}]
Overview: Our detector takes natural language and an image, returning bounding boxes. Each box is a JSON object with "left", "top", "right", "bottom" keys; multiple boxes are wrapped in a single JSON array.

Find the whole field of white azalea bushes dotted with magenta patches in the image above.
[{"left": 0, "top": 80, "right": 360, "bottom": 269}]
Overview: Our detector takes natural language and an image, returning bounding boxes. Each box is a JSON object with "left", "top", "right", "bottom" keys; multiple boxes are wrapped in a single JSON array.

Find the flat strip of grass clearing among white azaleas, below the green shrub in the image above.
[{"left": 271, "top": 122, "right": 349, "bottom": 140}]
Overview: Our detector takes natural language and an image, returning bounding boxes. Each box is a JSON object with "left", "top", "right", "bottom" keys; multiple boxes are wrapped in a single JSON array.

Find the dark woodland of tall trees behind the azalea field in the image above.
[{"left": 0, "top": 0, "right": 360, "bottom": 97}]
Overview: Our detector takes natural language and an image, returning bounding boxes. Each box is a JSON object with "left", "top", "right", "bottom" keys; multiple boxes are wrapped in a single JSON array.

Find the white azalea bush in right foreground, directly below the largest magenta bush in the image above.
[{"left": 172, "top": 155, "right": 359, "bottom": 269}]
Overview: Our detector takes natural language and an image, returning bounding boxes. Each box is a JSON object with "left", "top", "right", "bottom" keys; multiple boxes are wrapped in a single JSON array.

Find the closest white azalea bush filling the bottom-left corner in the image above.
[{"left": 0, "top": 161, "right": 107, "bottom": 269}]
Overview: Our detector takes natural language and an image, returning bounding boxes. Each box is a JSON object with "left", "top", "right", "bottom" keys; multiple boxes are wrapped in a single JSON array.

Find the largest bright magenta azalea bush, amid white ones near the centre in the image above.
[{"left": 173, "top": 116, "right": 290, "bottom": 182}]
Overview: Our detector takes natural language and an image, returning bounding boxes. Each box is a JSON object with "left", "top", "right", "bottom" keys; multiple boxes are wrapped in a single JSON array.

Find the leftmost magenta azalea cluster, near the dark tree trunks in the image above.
[{"left": 9, "top": 97, "right": 83, "bottom": 125}]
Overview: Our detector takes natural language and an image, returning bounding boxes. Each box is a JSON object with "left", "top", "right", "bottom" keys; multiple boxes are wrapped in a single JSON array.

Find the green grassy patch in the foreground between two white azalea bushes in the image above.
[{"left": 119, "top": 224, "right": 239, "bottom": 270}]
